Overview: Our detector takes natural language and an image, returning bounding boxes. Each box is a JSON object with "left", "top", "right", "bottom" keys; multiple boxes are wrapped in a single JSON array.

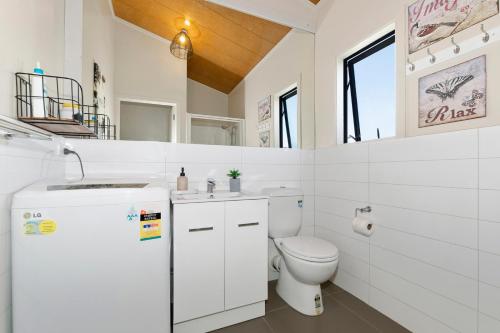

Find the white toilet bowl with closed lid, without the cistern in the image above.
[{"left": 273, "top": 236, "right": 338, "bottom": 316}]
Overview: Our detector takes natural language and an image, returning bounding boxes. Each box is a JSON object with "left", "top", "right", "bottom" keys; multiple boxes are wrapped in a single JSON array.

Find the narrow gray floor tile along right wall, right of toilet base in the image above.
[{"left": 328, "top": 292, "right": 410, "bottom": 333}]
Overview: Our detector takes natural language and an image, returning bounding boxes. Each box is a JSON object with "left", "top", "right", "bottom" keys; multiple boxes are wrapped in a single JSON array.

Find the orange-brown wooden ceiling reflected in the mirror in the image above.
[{"left": 113, "top": 0, "right": 290, "bottom": 94}]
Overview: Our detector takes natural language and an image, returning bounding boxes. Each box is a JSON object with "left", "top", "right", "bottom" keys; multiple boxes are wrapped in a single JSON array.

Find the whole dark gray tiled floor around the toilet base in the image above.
[{"left": 215, "top": 282, "right": 409, "bottom": 333}]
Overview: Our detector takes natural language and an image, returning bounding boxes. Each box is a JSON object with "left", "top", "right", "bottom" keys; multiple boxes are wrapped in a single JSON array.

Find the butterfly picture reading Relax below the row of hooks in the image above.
[{"left": 418, "top": 55, "right": 487, "bottom": 128}]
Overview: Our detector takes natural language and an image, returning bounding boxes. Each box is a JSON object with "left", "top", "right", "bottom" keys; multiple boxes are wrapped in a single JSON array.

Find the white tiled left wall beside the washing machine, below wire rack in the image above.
[{"left": 0, "top": 139, "right": 65, "bottom": 333}]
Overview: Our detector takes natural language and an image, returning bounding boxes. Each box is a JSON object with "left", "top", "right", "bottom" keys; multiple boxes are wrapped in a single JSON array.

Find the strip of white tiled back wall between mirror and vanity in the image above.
[{"left": 66, "top": 140, "right": 308, "bottom": 196}]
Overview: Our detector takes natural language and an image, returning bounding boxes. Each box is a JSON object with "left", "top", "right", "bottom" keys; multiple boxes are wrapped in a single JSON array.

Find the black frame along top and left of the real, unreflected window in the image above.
[{"left": 343, "top": 30, "right": 396, "bottom": 143}]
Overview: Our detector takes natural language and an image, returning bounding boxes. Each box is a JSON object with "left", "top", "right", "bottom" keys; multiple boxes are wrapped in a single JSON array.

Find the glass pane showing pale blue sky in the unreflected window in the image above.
[{"left": 354, "top": 44, "right": 396, "bottom": 141}]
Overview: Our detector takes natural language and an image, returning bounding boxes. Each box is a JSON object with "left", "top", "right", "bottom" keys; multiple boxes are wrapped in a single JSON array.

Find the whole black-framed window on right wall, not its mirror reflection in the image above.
[{"left": 343, "top": 31, "right": 396, "bottom": 143}]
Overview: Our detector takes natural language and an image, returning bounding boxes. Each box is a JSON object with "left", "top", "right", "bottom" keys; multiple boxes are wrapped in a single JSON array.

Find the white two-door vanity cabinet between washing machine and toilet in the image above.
[{"left": 172, "top": 197, "right": 268, "bottom": 333}]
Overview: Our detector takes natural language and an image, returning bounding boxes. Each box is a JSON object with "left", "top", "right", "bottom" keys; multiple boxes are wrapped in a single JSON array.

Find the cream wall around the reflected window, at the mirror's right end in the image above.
[{"left": 229, "top": 29, "right": 314, "bottom": 149}]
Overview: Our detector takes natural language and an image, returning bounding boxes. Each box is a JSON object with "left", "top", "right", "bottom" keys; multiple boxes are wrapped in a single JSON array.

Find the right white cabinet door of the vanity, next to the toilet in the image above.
[{"left": 225, "top": 200, "right": 268, "bottom": 310}]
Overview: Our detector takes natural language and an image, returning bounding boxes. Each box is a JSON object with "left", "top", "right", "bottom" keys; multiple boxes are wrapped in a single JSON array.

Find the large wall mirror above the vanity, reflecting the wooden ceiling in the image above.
[{"left": 102, "top": 0, "right": 314, "bottom": 148}]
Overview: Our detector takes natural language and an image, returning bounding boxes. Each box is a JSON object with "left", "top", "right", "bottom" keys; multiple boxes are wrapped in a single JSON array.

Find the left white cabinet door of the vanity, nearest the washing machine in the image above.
[{"left": 173, "top": 202, "right": 224, "bottom": 323}]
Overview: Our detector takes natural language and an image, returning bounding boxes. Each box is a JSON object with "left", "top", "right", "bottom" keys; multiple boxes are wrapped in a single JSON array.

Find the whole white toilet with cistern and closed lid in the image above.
[{"left": 263, "top": 188, "right": 339, "bottom": 316}]
